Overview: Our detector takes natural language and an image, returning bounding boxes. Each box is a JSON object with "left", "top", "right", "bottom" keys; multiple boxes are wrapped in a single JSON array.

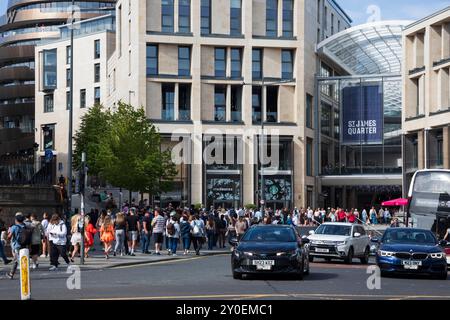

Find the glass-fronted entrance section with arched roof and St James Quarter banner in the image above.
[{"left": 314, "top": 21, "right": 409, "bottom": 209}]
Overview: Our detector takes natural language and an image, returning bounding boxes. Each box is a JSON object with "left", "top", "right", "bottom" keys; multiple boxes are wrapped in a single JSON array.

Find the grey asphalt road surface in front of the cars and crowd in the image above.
[{"left": 0, "top": 254, "right": 450, "bottom": 301}]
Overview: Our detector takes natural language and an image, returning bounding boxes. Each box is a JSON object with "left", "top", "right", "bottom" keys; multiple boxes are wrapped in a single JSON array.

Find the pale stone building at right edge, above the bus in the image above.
[{"left": 403, "top": 7, "right": 450, "bottom": 190}]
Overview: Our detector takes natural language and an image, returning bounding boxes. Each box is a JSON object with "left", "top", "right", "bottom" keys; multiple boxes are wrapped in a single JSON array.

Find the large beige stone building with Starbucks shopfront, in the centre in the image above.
[{"left": 107, "top": 0, "right": 351, "bottom": 208}]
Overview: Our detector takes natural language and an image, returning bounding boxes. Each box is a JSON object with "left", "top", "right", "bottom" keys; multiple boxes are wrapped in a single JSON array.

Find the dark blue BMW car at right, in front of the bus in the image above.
[{"left": 376, "top": 228, "right": 447, "bottom": 280}]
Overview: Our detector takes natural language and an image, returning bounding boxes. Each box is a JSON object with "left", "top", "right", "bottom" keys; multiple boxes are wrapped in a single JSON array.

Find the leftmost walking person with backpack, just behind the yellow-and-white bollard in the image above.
[{"left": 6, "top": 212, "right": 31, "bottom": 280}]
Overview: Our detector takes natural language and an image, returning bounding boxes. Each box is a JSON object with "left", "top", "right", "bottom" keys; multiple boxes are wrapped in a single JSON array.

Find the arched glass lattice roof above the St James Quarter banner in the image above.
[{"left": 316, "top": 21, "right": 411, "bottom": 75}]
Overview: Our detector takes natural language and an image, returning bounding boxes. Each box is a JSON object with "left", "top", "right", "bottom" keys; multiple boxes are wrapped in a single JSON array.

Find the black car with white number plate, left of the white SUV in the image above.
[{"left": 230, "top": 225, "right": 309, "bottom": 279}]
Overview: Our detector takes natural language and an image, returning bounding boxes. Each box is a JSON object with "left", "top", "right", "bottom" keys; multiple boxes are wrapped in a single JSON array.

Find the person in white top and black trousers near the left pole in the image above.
[{"left": 47, "top": 214, "right": 70, "bottom": 271}]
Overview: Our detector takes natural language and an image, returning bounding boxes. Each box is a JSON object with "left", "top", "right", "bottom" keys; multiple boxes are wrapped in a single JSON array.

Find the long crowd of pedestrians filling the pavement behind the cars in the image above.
[{"left": 0, "top": 200, "right": 399, "bottom": 279}]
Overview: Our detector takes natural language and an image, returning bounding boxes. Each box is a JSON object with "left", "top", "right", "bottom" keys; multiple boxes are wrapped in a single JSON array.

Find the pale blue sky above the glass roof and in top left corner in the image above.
[{"left": 0, "top": 0, "right": 450, "bottom": 25}]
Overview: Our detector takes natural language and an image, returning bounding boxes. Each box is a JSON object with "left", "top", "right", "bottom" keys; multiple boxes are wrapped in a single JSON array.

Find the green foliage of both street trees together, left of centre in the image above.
[{"left": 75, "top": 103, "right": 177, "bottom": 195}]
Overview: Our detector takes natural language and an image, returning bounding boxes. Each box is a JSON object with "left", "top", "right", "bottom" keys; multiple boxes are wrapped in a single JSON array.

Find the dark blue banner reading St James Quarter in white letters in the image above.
[{"left": 341, "top": 84, "right": 383, "bottom": 145}]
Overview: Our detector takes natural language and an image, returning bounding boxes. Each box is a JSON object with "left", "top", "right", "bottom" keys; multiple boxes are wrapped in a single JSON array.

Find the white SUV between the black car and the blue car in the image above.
[{"left": 308, "top": 222, "right": 370, "bottom": 264}]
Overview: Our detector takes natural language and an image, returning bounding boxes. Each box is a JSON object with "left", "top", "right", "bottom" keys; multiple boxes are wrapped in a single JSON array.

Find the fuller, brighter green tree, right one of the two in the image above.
[{"left": 96, "top": 103, "right": 177, "bottom": 195}]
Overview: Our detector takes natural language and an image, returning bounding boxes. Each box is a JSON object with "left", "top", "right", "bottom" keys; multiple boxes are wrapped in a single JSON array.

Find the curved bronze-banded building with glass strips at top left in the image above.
[{"left": 0, "top": 0, "right": 115, "bottom": 156}]
